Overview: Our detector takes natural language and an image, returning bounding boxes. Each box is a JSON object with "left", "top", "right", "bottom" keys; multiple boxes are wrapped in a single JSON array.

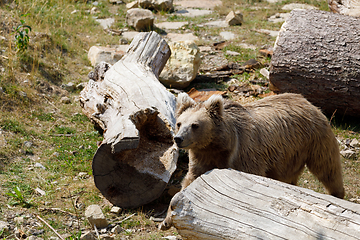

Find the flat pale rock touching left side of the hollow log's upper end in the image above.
[{"left": 88, "top": 46, "right": 125, "bottom": 66}]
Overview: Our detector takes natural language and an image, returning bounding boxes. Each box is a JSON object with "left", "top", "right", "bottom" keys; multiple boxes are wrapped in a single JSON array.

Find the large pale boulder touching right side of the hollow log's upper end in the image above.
[{"left": 159, "top": 41, "right": 201, "bottom": 89}]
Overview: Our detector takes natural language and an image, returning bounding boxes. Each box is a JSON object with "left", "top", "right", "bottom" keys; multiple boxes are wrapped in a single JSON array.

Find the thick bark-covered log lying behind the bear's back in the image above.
[{"left": 270, "top": 10, "right": 360, "bottom": 116}]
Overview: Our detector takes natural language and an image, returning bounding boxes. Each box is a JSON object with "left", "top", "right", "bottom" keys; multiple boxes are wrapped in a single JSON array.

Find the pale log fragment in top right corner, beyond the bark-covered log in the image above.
[{"left": 328, "top": 0, "right": 360, "bottom": 17}]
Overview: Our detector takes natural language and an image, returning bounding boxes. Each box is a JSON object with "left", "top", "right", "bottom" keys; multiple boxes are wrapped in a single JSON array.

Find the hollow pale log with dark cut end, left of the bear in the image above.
[{"left": 80, "top": 32, "right": 178, "bottom": 208}]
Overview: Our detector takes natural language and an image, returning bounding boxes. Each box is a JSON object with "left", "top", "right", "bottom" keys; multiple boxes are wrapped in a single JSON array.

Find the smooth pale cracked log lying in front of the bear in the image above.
[{"left": 170, "top": 169, "right": 360, "bottom": 240}]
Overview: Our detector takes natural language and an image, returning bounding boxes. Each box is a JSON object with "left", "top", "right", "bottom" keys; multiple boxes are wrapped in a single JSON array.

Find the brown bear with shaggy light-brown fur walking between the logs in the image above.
[{"left": 160, "top": 93, "right": 344, "bottom": 229}]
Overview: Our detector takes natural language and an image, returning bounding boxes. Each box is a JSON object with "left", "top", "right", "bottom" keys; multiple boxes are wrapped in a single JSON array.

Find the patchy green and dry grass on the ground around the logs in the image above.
[{"left": 0, "top": 0, "right": 360, "bottom": 239}]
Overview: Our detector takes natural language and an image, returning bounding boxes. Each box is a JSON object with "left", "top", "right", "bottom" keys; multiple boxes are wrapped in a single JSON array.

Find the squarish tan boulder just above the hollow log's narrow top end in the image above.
[{"left": 126, "top": 8, "right": 154, "bottom": 31}]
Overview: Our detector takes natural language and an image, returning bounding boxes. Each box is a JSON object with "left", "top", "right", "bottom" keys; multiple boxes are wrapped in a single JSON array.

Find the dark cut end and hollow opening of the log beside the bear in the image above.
[{"left": 93, "top": 111, "right": 178, "bottom": 208}]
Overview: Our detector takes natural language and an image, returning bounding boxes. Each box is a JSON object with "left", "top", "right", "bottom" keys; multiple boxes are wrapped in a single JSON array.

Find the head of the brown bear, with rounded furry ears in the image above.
[{"left": 174, "top": 93, "right": 224, "bottom": 149}]
